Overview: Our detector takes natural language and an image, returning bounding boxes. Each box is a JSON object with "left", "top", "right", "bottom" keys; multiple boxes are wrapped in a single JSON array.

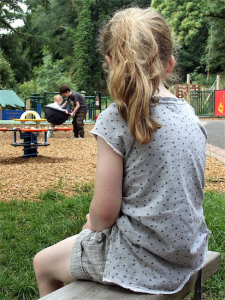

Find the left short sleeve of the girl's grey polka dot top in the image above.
[{"left": 90, "top": 103, "right": 130, "bottom": 157}]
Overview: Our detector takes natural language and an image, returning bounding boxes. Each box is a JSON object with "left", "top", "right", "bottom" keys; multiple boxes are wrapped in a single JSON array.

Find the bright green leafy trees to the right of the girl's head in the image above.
[{"left": 152, "top": 0, "right": 225, "bottom": 79}]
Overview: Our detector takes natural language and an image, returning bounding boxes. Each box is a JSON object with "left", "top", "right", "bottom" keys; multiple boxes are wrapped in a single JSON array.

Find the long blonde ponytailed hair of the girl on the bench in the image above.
[{"left": 100, "top": 8, "right": 173, "bottom": 144}]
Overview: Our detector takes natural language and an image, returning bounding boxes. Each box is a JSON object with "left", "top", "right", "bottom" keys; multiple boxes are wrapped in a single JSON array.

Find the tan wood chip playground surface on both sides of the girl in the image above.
[{"left": 0, "top": 124, "right": 225, "bottom": 201}]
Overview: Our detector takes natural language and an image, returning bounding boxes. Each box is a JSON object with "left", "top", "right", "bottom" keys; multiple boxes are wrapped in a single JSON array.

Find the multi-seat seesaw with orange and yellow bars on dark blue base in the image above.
[{"left": 0, "top": 110, "right": 72, "bottom": 157}]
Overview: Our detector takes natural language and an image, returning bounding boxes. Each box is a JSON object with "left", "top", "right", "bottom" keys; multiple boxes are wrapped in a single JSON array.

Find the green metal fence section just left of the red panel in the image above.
[{"left": 190, "top": 90, "right": 215, "bottom": 117}]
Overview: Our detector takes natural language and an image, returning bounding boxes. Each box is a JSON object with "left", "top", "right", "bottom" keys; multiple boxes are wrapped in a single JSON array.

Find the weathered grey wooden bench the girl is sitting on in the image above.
[{"left": 40, "top": 251, "right": 221, "bottom": 300}]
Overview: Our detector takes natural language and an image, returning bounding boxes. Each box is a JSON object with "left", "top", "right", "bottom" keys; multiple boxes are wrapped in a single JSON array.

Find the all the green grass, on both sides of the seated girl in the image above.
[{"left": 0, "top": 185, "right": 225, "bottom": 300}]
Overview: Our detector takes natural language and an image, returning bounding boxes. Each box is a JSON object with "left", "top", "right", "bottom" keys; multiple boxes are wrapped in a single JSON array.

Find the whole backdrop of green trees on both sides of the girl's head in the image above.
[{"left": 0, "top": 0, "right": 225, "bottom": 94}]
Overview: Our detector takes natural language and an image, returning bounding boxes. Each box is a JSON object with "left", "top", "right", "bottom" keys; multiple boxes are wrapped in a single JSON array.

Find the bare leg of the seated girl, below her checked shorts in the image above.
[{"left": 33, "top": 236, "right": 76, "bottom": 297}]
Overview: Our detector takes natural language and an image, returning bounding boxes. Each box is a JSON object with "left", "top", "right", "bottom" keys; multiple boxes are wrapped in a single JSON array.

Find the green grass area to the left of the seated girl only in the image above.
[{"left": 0, "top": 185, "right": 92, "bottom": 300}]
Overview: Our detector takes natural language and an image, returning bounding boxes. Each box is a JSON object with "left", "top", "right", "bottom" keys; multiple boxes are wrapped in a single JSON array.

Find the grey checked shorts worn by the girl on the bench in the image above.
[{"left": 70, "top": 229, "right": 110, "bottom": 284}]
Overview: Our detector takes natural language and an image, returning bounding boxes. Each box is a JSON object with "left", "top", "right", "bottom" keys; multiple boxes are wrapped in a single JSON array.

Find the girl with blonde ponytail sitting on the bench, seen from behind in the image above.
[{"left": 34, "top": 8, "right": 209, "bottom": 296}]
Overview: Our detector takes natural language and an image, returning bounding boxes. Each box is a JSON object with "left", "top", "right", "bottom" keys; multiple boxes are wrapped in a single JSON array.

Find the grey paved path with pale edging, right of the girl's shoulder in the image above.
[{"left": 201, "top": 120, "right": 225, "bottom": 164}]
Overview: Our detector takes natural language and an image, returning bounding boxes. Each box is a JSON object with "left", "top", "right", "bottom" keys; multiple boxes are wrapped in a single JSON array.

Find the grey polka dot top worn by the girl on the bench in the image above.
[{"left": 89, "top": 98, "right": 209, "bottom": 294}]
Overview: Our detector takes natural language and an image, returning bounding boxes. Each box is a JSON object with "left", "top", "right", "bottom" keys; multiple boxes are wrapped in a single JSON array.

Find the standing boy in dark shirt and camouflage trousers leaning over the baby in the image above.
[{"left": 59, "top": 85, "right": 88, "bottom": 138}]
